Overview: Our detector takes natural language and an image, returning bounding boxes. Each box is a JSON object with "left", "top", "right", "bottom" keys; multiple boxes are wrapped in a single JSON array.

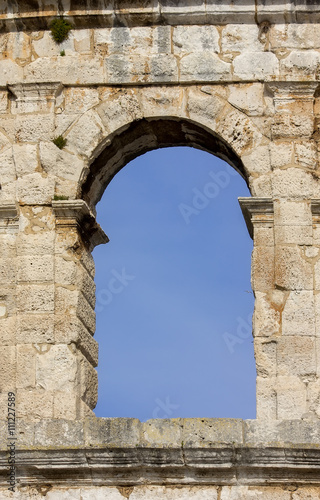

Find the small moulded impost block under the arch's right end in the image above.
[{"left": 238, "top": 198, "right": 274, "bottom": 238}]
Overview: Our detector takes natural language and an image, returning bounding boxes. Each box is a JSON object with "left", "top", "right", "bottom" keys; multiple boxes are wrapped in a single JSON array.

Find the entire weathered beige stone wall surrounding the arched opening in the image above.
[{"left": 0, "top": 0, "right": 320, "bottom": 500}]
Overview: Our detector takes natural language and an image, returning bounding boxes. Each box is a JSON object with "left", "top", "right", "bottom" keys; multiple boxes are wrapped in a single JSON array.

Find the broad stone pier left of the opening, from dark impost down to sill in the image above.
[{"left": 0, "top": 200, "right": 108, "bottom": 421}]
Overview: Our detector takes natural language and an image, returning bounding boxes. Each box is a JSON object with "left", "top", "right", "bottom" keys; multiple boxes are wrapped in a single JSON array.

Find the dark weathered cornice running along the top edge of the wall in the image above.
[{"left": 0, "top": 0, "right": 320, "bottom": 32}]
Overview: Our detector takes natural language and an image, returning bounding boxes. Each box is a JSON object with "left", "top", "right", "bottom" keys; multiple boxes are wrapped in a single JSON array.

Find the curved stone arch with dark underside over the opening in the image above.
[{"left": 58, "top": 84, "right": 271, "bottom": 209}]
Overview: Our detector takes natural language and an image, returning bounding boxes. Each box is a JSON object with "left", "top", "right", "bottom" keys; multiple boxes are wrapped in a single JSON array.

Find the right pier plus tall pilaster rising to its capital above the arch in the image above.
[{"left": 241, "top": 68, "right": 320, "bottom": 420}]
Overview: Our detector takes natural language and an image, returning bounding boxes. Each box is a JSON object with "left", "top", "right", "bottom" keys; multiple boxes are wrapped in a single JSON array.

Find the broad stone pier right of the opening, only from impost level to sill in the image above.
[{"left": 240, "top": 193, "right": 320, "bottom": 420}]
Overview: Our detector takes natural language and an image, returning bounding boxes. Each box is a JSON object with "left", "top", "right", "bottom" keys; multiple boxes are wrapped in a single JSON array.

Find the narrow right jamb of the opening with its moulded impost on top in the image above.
[{"left": 239, "top": 198, "right": 282, "bottom": 420}]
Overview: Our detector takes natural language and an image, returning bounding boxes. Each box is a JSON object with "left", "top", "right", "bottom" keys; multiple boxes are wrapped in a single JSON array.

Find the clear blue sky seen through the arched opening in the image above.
[{"left": 94, "top": 147, "right": 256, "bottom": 421}]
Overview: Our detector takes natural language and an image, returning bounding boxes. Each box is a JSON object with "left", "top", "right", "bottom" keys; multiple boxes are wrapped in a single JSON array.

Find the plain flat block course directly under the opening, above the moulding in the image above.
[{"left": 0, "top": 417, "right": 320, "bottom": 451}]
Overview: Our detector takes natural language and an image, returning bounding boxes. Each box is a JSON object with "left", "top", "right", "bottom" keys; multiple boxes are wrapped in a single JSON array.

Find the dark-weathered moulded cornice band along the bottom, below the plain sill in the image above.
[{"left": 0, "top": 444, "right": 320, "bottom": 487}]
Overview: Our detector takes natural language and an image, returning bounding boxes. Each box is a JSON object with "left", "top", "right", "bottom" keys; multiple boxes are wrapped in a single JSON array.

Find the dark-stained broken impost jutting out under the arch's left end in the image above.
[{"left": 52, "top": 200, "right": 109, "bottom": 250}]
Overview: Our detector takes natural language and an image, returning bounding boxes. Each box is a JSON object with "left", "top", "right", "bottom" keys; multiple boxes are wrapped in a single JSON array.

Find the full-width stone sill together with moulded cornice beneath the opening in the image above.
[{"left": 0, "top": 418, "right": 320, "bottom": 488}]
